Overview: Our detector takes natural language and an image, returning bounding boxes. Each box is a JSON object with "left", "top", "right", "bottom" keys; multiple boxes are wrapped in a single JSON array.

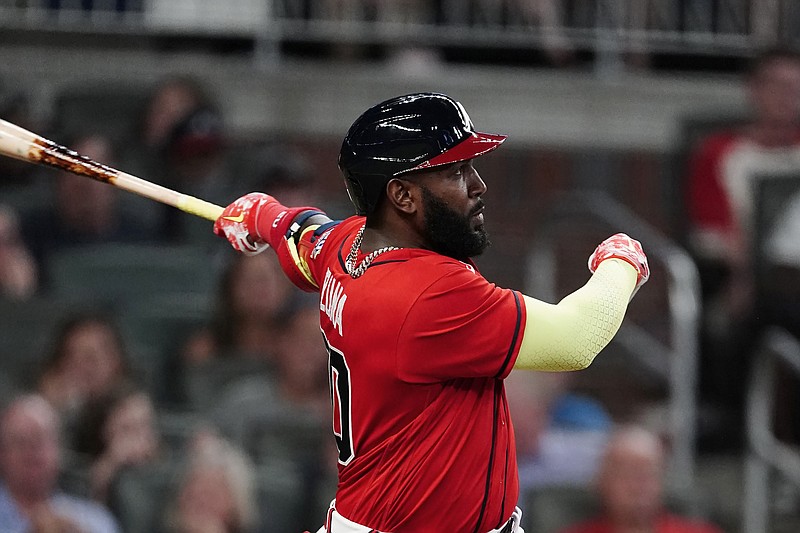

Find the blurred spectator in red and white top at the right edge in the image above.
[{"left": 687, "top": 50, "right": 800, "bottom": 445}]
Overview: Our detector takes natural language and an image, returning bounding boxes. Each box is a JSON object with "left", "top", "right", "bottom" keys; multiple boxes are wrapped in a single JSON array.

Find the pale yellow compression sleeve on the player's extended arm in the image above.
[{"left": 514, "top": 259, "right": 637, "bottom": 371}]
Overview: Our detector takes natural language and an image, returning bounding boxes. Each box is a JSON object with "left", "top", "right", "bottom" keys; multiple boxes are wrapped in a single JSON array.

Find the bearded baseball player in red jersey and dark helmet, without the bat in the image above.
[{"left": 214, "top": 93, "right": 649, "bottom": 533}]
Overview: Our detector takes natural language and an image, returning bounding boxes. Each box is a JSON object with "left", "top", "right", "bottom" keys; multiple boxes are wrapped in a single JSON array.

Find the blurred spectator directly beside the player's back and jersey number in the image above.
[{"left": 210, "top": 295, "right": 338, "bottom": 529}]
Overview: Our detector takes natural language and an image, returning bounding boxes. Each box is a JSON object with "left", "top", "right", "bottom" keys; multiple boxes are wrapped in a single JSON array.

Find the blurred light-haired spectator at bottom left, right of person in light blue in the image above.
[{"left": 163, "top": 431, "right": 258, "bottom": 533}]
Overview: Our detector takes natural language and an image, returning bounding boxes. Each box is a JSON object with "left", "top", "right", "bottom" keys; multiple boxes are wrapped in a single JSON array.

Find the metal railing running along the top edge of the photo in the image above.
[{"left": 0, "top": 0, "right": 800, "bottom": 61}]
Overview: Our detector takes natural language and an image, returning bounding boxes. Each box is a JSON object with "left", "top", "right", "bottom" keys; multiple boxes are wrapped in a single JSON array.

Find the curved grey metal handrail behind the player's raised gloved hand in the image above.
[{"left": 526, "top": 192, "right": 701, "bottom": 488}]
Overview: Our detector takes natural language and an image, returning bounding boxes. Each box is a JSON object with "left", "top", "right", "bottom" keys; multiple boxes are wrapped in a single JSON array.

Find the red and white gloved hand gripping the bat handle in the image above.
[{"left": 214, "top": 192, "right": 271, "bottom": 255}]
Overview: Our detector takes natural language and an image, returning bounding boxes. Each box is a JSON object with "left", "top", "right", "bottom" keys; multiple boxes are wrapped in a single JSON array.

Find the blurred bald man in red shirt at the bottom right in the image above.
[{"left": 562, "top": 427, "right": 721, "bottom": 533}]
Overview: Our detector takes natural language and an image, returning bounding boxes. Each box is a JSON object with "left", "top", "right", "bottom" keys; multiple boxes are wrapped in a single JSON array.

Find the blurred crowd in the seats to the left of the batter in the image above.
[{"left": 0, "top": 76, "right": 336, "bottom": 533}]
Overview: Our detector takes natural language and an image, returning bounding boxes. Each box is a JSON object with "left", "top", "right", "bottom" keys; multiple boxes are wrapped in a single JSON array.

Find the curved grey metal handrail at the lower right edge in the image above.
[{"left": 742, "top": 328, "right": 800, "bottom": 533}]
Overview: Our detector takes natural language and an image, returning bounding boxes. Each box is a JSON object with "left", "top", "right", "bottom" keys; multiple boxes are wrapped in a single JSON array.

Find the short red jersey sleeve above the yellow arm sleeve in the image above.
[{"left": 396, "top": 264, "right": 525, "bottom": 383}]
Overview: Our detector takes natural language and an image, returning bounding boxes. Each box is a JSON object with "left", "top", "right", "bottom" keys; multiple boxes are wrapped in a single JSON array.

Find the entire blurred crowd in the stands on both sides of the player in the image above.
[{"left": 0, "top": 43, "right": 800, "bottom": 533}]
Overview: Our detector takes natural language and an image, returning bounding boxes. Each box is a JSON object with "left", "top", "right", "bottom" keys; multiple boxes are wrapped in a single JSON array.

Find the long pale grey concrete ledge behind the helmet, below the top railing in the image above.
[{"left": 0, "top": 45, "right": 745, "bottom": 152}]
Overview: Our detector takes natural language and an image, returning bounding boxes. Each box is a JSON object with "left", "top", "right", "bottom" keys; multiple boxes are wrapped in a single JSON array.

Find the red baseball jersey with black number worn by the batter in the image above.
[{"left": 290, "top": 217, "right": 525, "bottom": 533}]
